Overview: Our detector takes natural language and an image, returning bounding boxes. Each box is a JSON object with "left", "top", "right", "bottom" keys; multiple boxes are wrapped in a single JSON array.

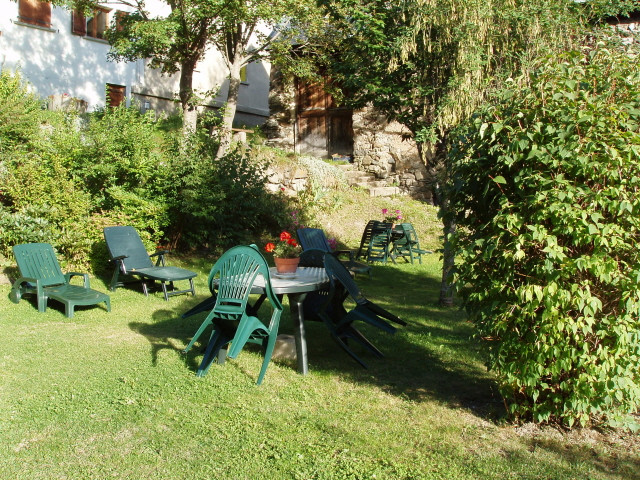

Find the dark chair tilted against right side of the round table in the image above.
[{"left": 318, "top": 255, "right": 406, "bottom": 368}]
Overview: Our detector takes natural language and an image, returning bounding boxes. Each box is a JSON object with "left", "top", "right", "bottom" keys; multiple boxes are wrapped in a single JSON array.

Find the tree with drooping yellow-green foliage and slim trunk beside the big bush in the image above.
[{"left": 321, "top": 0, "right": 582, "bottom": 305}]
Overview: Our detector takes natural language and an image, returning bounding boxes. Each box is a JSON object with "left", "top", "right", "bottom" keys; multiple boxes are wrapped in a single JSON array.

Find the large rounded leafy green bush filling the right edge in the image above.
[{"left": 450, "top": 44, "right": 640, "bottom": 426}]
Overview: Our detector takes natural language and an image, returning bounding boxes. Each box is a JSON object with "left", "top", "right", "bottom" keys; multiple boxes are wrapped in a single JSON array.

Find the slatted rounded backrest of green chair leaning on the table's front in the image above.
[{"left": 208, "top": 245, "right": 282, "bottom": 321}]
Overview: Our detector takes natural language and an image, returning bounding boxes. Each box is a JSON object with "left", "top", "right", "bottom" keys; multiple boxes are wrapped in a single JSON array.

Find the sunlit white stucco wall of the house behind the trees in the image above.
[{"left": 0, "top": 0, "right": 270, "bottom": 126}]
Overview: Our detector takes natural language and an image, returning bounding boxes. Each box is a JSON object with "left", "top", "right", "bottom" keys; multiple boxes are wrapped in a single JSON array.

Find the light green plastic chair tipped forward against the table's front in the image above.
[{"left": 183, "top": 245, "right": 282, "bottom": 385}]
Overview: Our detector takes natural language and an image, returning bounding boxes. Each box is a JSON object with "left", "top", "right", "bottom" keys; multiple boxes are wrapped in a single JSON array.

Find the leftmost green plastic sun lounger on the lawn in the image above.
[{"left": 9, "top": 243, "right": 111, "bottom": 318}]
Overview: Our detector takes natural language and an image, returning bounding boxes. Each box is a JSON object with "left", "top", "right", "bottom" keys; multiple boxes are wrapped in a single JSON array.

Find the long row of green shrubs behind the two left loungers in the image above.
[{"left": 0, "top": 72, "right": 293, "bottom": 270}]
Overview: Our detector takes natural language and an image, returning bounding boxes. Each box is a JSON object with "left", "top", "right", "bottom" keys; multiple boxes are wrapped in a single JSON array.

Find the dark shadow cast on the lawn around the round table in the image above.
[{"left": 130, "top": 265, "right": 504, "bottom": 420}]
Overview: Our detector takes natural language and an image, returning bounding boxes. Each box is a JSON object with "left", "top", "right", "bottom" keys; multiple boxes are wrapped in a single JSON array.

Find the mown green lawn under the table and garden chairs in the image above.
[{"left": 0, "top": 200, "right": 640, "bottom": 480}]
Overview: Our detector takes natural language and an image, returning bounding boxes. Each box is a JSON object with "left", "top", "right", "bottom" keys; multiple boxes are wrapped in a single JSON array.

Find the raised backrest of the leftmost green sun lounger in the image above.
[{"left": 13, "top": 243, "right": 67, "bottom": 287}]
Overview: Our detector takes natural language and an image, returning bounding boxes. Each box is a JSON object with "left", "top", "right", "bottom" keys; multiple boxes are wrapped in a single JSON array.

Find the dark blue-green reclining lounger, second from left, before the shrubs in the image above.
[{"left": 104, "top": 226, "right": 197, "bottom": 300}]
